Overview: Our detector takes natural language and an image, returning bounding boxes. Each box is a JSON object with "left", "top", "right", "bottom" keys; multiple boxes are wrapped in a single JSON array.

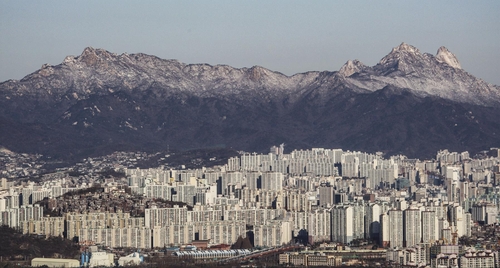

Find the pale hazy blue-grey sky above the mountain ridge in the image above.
[{"left": 0, "top": 0, "right": 500, "bottom": 85}]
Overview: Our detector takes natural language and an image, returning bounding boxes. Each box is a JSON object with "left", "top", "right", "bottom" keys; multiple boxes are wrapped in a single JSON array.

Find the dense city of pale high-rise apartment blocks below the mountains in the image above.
[{"left": 0, "top": 144, "right": 500, "bottom": 267}]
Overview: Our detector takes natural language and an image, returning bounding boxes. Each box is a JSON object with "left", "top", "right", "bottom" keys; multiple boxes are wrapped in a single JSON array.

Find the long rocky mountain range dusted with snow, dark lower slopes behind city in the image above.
[{"left": 0, "top": 43, "right": 500, "bottom": 159}]
